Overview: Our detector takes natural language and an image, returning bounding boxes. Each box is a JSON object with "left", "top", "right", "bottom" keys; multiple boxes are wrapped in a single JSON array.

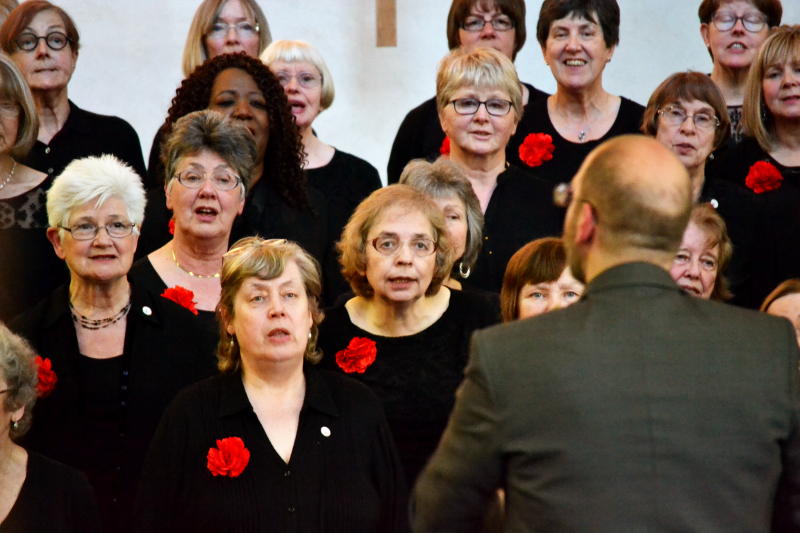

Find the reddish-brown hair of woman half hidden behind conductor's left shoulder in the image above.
[{"left": 500, "top": 237, "right": 567, "bottom": 322}]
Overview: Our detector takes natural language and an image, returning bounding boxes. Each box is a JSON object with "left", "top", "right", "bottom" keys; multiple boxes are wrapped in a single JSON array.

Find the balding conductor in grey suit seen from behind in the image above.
[{"left": 412, "top": 136, "right": 800, "bottom": 533}]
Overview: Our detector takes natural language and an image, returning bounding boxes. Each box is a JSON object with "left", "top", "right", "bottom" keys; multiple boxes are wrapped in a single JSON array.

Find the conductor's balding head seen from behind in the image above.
[{"left": 573, "top": 135, "right": 692, "bottom": 254}]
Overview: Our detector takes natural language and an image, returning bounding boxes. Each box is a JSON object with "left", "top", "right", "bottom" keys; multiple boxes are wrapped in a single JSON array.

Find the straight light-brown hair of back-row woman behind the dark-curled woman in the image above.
[{"left": 183, "top": 0, "right": 272, "bottom": 76}]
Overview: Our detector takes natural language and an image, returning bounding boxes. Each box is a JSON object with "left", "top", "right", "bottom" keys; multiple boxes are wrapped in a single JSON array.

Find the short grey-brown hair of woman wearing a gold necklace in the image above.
[{"left": 161, "top": 109, "right": 257, "bottom": 198}]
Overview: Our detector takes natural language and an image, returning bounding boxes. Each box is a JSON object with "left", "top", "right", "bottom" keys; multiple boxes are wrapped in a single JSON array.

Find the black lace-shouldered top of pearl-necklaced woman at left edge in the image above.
[{"left": 0, "top": 172, "right": 69, "bottom": 322}]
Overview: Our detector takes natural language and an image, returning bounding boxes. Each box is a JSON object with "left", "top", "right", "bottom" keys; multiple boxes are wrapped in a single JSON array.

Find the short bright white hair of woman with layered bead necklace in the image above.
[{"left": 47, "top": 154, "right": 147, "bottom": 227}]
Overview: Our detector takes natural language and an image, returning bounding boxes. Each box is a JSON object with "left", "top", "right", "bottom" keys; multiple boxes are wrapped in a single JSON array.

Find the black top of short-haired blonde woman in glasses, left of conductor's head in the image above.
[{"left": 467, "top": 165, "right": 565, "bottom": 293}]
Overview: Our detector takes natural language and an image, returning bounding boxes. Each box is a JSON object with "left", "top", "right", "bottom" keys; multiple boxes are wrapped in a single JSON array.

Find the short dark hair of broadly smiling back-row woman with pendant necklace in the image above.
[{"left": 536, "top": 0, "right": 619, "bottom": 48}]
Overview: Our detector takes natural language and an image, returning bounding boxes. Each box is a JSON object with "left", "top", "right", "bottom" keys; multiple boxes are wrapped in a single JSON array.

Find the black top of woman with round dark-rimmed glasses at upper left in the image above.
[{"left": 22, "top": 100, "right": 146, "bottom": 177}]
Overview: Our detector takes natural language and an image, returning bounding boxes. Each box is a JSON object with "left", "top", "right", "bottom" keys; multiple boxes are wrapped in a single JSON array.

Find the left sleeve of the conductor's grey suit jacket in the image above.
[{"left": 411, "top": 333, "right": 503, "bottom": 533}]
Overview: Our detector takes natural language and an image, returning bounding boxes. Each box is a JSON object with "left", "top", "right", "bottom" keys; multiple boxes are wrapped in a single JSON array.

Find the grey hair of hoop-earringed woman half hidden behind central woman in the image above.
[{"left": 399, "top": 157, "right": 483, "bottom": 274}]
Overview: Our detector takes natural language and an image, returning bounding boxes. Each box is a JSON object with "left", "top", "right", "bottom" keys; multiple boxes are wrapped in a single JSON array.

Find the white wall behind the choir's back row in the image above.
[{"left": 55, "top": 0, "right": 800, "bottom": 181}]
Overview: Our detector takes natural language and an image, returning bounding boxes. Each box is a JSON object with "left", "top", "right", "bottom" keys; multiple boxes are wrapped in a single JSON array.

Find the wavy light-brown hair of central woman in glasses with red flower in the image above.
[{"left": 337, "top": 184, "right": 453, "bottom": 298}]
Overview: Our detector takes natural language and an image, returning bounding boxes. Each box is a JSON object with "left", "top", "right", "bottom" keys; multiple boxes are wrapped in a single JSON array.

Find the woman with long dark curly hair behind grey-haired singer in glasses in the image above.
[{"left": 139, "top": 53, "right": 327, "bottom": 261}]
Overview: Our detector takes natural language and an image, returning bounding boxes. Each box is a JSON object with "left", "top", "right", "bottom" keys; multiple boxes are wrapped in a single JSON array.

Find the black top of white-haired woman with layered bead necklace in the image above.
[{"left": 11, "top": 284, "right": 216, "bottom": 533}]
